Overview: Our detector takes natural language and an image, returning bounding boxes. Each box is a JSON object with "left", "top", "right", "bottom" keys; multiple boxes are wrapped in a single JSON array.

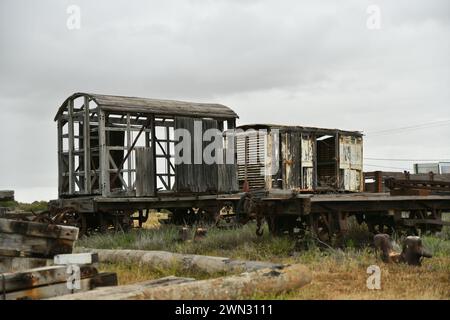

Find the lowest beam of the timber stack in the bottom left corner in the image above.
[{"left": 4, "top": 272, "right": 117, "bottom": 300}]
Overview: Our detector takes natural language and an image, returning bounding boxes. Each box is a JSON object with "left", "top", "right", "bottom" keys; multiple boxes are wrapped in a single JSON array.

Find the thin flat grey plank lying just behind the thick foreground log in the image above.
[{"left": 51, "top": 276, "right": 195, "bottom": 300}]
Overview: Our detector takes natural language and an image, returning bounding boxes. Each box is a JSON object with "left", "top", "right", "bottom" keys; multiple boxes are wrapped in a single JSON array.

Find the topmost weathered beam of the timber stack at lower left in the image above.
[{"left": 0, "top": 219, "right": 78, "bottom": 240}]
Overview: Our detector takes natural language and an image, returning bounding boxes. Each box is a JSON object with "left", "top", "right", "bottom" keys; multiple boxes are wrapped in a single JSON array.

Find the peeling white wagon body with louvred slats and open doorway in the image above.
[{"left": 236, "top": 124, "right": 364, "bottom": 193}]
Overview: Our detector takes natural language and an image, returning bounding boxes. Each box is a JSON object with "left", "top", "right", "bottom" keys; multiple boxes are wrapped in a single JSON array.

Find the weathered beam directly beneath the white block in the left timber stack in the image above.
[{"left": 0, "top": 266, "right": 98, "bottom": 292}]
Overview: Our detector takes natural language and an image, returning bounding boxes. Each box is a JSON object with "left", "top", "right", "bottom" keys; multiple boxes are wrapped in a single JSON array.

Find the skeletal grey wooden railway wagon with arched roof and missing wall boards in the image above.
[{"left": 46, "top": 93, "right": 238, "bottom": 233}]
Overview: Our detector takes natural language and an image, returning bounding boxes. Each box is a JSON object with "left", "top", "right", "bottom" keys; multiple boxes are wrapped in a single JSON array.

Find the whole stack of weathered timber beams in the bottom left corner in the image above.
[{"left": 0, "top": 219, "right": 117, "bottom": 300}]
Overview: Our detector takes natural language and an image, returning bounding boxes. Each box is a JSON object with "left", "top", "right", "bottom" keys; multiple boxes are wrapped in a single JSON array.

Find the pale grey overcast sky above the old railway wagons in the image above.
[{"left": 0, "top": 0, "right": 450, "bottom": 201}]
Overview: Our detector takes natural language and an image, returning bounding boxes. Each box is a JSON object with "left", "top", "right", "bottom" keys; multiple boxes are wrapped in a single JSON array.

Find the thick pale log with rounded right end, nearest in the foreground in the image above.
[{"left": 50, "top": 264, "right": 311, "bottom": 300}]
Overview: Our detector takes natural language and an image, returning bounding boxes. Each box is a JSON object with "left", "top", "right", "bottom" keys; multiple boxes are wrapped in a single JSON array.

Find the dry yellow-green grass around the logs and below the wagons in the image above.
[{"left": 78, "top": 215, "right": 450, "bottom": 299}]
